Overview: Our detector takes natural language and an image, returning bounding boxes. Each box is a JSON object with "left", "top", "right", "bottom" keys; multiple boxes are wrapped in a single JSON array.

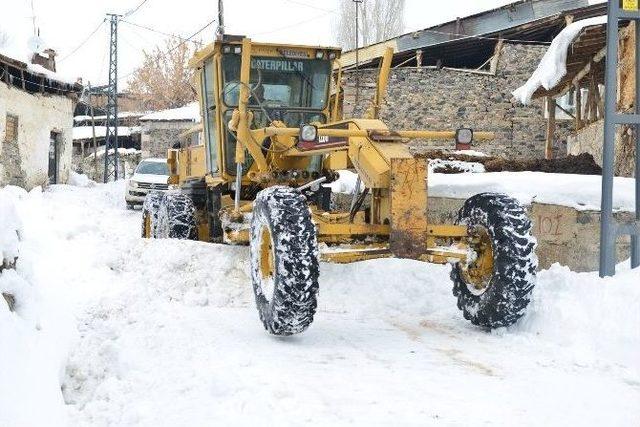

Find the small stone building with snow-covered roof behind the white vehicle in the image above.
[{"left": 140, "top": 102, "right": 200, "bottom": 158}]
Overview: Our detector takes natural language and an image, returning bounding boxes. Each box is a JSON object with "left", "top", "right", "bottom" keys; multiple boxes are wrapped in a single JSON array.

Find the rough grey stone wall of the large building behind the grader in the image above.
[{"left": 343, "top": 43, "right": 572, "bottom": 158}]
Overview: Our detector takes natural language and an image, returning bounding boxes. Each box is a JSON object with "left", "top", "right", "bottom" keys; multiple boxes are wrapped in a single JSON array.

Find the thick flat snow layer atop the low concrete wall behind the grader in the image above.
[{"left": 429, "top": 172, "right": 635, "bottom": 212}]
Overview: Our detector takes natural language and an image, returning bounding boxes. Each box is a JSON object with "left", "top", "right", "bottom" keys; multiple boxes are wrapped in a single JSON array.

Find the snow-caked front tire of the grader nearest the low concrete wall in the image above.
[{"left": 451, "top": 193, "right": 538, "bottom": 328}]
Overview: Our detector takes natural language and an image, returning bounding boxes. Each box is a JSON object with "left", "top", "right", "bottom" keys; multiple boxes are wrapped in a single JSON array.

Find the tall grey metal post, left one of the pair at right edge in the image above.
[{"left": 600, "top": 1, "right": 619, "bottom": 277}]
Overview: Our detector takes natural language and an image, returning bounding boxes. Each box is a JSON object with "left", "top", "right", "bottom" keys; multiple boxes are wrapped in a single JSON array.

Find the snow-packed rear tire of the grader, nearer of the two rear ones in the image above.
[{"left": 155, "top": 193, "right": 198, "bottom": 240}]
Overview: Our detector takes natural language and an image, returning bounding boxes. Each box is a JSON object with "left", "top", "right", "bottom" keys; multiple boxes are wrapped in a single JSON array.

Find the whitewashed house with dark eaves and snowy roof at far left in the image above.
[{"left": 0, "top": 51, "right": 82, "bottom": 189}]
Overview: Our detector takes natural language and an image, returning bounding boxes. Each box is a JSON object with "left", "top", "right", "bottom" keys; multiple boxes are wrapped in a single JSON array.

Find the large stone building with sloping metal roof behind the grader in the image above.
[{"left": 341, "top": 0, "right": 606, "bottom": 159}]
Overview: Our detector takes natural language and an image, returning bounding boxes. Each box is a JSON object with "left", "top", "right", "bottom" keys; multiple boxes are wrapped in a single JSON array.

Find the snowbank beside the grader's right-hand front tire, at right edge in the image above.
[{"left": 511, "top": 261, "right": 640, "bottom": 370}]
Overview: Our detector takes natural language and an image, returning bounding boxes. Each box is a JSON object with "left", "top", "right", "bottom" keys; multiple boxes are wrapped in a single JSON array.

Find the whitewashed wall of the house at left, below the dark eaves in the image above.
[{"left": 0, "top": 83, "right": 74, "bottom": 189}]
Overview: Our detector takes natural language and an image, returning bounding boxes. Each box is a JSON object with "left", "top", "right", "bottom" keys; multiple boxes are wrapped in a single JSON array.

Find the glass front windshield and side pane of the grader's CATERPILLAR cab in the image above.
[{"left": 222, "top": 54, "right": 331, "bottom": 110}]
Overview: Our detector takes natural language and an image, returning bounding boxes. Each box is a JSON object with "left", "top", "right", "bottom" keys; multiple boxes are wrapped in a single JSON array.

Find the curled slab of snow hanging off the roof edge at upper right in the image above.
[{"left": 512, "top": 16, "right": 607, "bottom": 104}]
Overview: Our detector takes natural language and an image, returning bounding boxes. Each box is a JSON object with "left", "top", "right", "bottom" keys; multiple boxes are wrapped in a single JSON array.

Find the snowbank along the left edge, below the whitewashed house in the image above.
[{"left": 0, "top": 187, "right": 70, "bottom": 426}]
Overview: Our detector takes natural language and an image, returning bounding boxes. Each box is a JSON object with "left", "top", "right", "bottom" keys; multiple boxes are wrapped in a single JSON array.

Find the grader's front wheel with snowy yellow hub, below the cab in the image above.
[{"left": 251, "top": 186, "right": 319, "bottom": 335}]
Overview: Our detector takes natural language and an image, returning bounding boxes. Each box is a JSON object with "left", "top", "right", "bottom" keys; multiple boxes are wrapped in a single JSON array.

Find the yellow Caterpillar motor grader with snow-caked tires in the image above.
[{"left": 142, "top": 36, "right": 537, "bottom": 335}]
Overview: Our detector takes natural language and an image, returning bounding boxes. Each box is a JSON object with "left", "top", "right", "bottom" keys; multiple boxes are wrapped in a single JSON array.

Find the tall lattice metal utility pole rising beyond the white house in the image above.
[{"left": 104, "top": 13, "right": 120, "bottom": 183}]
